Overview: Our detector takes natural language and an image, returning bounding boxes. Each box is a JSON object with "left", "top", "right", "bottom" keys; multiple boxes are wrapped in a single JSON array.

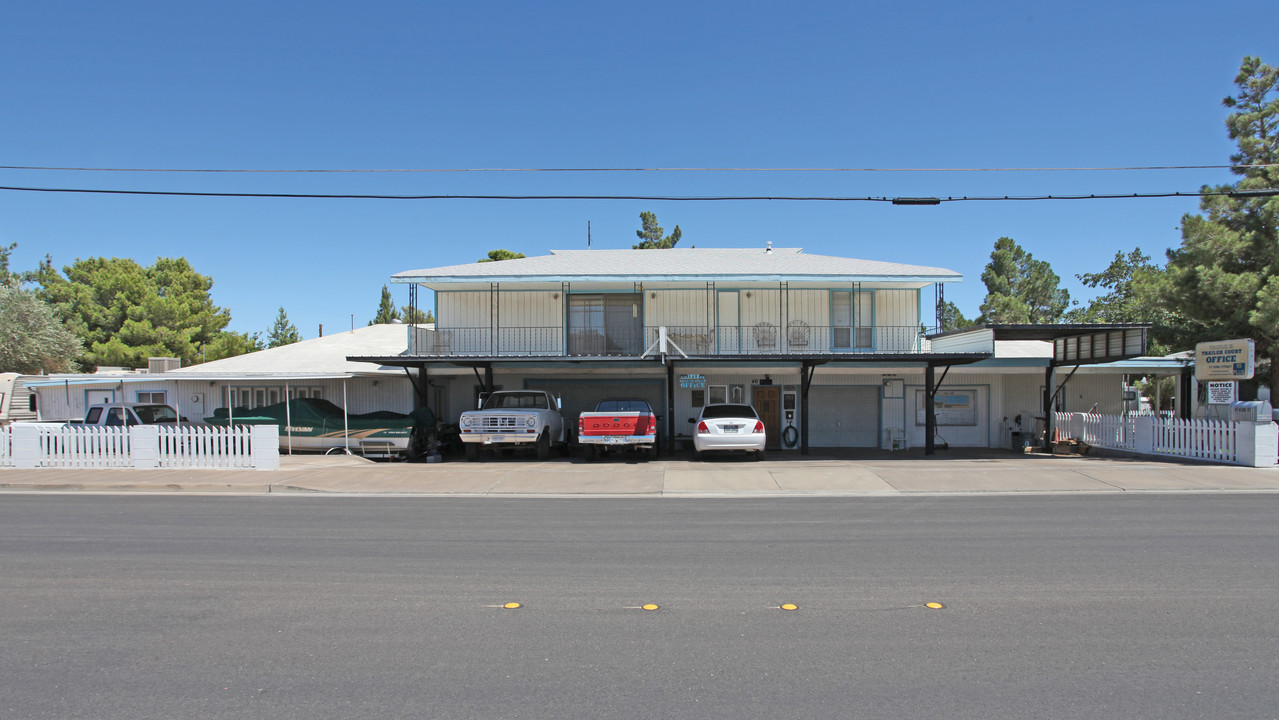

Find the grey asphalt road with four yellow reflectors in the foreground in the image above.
[{"left": 0, "top": 495, "right": 1279, "bottom": 720}]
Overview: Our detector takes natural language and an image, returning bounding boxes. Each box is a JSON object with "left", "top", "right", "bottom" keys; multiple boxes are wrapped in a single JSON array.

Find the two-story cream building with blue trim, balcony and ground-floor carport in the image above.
[{"left": 350, "top": 243, "right": 1175, "bottom": 450}]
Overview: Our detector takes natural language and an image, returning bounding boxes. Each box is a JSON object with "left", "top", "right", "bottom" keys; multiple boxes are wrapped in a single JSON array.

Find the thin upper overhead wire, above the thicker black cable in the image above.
[{"left": 0, "top": 164, "right": 1279, "bottom": 174}]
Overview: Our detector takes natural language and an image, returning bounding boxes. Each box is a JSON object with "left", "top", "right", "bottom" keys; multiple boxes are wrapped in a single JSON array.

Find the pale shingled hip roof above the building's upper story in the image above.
[{"left": 391, "top": 248, "right": 963, "bottom": 285}]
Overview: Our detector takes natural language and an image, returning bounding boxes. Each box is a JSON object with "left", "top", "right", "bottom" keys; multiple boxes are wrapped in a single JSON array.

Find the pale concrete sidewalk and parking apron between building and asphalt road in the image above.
[{"left": 0, "top": 450, "right": 1279, "bottom": 497}]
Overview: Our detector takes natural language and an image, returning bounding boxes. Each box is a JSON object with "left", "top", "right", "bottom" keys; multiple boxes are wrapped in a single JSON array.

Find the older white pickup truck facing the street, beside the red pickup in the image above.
[{"left": 458, "top": 390, "right": 568, "bottom": 462}]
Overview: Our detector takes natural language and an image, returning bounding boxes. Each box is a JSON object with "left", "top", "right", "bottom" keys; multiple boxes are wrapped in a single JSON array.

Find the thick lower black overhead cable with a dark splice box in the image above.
[{"left": 0, "top": 185, "right": 1279, "bottom": 205}]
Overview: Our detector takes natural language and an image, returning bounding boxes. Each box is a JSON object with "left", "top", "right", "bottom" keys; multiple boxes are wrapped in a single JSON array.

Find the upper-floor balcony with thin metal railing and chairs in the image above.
[{"left": 408, "top": 321, "right": 930, "bottom": 359}]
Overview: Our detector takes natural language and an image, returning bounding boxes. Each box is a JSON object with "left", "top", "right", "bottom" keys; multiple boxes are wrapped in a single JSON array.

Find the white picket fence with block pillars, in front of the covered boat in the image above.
[{"left": 0, "top": 423, "right": 280, "bottom": 471}]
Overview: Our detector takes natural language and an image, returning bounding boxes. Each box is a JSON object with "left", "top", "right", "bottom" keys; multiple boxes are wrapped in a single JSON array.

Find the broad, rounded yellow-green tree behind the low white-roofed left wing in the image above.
[{"left": 36, "top": 257, "right": 230, "bottom": 367}]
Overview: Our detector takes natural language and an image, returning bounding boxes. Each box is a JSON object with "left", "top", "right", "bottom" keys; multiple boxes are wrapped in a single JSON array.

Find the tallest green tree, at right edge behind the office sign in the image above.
[{"left": 1141, "top": 56, "right": 1279, "bottom": 387}]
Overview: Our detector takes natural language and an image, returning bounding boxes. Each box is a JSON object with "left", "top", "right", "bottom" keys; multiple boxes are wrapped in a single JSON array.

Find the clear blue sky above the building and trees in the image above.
[{"left": 0, "top": 0, "right": 1279, "bottom": 338}]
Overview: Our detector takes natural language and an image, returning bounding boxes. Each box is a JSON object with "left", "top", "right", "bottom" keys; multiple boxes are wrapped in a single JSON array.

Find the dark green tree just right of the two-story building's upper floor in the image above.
[{"left": 981, "top": 238, "right": 1071, "bottom": 324}]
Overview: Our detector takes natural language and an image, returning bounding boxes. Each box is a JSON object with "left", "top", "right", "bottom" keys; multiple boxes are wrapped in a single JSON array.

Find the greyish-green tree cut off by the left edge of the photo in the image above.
[{"left": 0, "top": 282, "right": 81, "bottom": 375}]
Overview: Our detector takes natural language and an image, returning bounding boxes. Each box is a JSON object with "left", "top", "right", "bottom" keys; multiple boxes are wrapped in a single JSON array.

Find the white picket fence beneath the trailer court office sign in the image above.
[{"left": 1053, "top": 413, "right": 1276, "bottom": 467}]
